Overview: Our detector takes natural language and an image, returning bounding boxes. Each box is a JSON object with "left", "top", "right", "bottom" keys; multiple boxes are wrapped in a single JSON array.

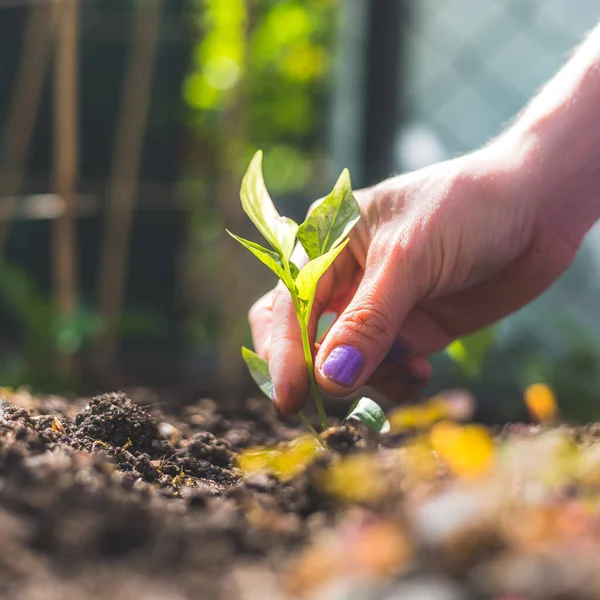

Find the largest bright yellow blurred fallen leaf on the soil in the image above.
[{"left": 429, "top": 421, "right": 495, "bottom": 477}]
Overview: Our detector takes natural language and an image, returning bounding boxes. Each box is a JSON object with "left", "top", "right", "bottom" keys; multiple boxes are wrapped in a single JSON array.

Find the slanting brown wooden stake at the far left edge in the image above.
[{"left": 0, "top": 4, "right": 57, "bottom": 254}]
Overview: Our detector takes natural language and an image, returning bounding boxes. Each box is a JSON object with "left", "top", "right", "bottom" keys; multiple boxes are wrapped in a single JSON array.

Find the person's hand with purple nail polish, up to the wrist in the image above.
[{"left": 250, "top": 139, "right": 578, "bottom": 414}]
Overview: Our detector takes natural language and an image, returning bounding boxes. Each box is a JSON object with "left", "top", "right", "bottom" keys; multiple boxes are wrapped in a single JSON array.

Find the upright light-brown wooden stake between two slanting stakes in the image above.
[{"left": 52, "top": 0, "right": 79, "bottom": 377}]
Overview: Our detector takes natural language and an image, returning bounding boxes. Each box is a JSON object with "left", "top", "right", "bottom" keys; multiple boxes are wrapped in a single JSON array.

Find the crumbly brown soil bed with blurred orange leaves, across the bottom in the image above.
[{"left": 0, "top": 390, "right": 600, "bottom": 600}]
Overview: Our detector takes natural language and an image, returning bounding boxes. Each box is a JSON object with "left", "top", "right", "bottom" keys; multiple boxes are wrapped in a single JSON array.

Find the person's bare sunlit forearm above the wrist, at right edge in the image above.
[{"left": 505, "top": 25, "right": 600, "bottom": 245}]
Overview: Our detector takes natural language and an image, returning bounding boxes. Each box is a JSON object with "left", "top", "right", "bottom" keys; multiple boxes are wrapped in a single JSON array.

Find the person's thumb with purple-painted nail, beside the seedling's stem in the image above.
[{"left": 316, "top": 239, "right": 415, "bottom": 396}]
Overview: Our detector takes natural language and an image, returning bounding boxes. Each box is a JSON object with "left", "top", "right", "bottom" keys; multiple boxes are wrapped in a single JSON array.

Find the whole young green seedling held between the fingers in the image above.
[{"left": 227, "top": 151, "right": 389, "bottom": 435}]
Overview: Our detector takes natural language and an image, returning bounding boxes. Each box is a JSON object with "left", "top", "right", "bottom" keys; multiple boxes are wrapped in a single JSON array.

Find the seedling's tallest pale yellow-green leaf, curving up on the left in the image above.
[{"left": 240, "top": 150, "right": 298, "bottom": 260}]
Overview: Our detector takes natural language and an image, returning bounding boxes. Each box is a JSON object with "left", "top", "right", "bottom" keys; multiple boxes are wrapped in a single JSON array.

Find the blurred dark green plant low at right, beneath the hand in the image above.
[{"left": 440, "top": 321, "right": 600, "bottom": 423}]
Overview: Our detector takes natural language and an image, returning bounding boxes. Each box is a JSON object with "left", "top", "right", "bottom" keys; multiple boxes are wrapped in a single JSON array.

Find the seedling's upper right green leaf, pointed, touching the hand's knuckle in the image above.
[{"left": 298, "top": 169, "right": 360, "bottom": 260}]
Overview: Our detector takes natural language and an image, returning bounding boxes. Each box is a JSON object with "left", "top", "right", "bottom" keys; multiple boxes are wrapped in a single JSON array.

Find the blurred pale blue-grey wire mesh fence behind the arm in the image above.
[{"left": 396, "top": 0, "right": 600, "bottom": 418}]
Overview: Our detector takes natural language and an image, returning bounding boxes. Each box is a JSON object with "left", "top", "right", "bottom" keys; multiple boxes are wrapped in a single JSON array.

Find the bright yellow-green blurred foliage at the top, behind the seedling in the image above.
[{"left": 183, "top": 0, "right": 338, "bottom": 193}]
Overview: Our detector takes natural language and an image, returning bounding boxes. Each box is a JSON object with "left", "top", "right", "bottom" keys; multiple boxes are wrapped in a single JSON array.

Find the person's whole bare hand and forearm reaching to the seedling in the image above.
[{"left": 249, "top": 26, "right": 600, "bottom": 414}]
